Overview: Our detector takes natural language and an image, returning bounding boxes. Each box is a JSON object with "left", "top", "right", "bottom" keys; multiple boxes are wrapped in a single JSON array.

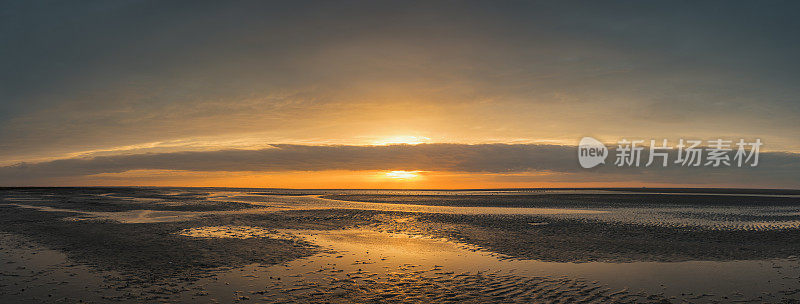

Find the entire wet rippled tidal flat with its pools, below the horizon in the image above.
[{"left": 0, "top": 188, "right": 800, "bottom": 303}]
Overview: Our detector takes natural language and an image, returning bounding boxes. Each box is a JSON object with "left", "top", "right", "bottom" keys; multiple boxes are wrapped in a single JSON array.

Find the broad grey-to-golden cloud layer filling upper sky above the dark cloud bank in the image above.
[{"left": 0, "top": 1, "right": 800, "bottom": 162}]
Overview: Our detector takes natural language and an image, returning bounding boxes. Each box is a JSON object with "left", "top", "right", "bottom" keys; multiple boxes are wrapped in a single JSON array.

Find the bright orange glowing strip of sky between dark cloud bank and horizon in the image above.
[{"left": 40, "top": 170, "right": 736, "bottom": 189}]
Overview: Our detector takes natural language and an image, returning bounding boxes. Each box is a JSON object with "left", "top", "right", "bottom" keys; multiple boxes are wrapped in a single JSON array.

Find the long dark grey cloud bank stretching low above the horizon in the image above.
[{"left": 0, "top": 144, "right": 800, "bottom": 187}]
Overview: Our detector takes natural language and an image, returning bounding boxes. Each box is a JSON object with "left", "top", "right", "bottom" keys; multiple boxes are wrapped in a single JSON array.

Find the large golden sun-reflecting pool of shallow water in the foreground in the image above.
[{"left": 184, "top": 227, "right": 800, "bottom": 302}]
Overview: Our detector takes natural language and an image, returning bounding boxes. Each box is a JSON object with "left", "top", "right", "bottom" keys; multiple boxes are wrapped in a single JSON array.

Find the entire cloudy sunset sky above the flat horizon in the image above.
[{"left": 0, "top": 1, "right": 800, "bottom": 188}]
